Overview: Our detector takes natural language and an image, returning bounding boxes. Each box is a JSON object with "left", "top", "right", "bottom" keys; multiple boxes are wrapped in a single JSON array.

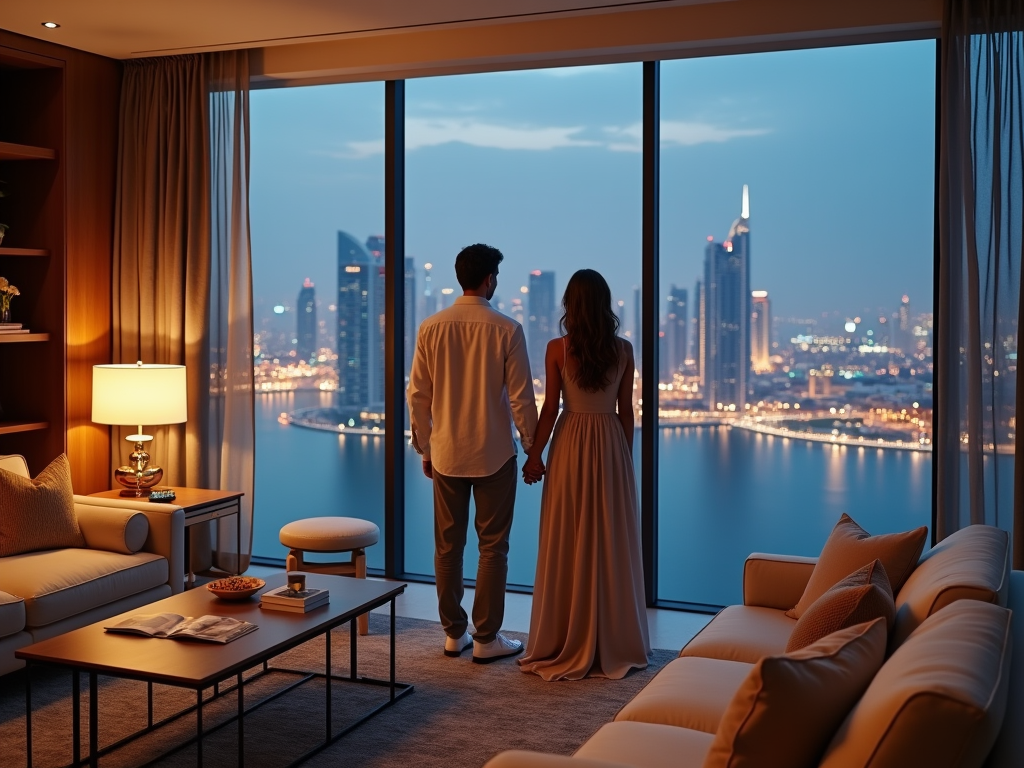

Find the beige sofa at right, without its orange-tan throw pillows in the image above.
[{"left": 486, "top": 525, "right": 1024, "bottom": 768}]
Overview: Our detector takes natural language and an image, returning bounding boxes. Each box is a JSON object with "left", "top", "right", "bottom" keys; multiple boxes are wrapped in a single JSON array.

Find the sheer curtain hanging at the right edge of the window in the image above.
[{"left": 935, "top": 0, "right": 1024, "bottom": 568}]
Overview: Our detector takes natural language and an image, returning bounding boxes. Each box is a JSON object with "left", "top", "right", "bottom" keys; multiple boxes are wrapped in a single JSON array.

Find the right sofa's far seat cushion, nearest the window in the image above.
[{"left": 679, "top": 605, "right": 797, "bottom": 664}]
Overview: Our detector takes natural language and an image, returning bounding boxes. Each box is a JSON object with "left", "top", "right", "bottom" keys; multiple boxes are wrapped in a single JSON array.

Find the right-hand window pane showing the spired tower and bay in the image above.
[{"left": 657, "top": 41, "right": 935, "bottom": 604}]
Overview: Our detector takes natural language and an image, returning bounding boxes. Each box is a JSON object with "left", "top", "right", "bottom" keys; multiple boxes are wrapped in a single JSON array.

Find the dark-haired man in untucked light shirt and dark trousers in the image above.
[{"left": 409, "top": 244, "right": 537, "bottom": 664}]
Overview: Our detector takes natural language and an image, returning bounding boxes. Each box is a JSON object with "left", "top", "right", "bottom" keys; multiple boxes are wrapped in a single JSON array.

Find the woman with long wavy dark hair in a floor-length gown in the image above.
[{"left": 519, "top": 269, "right": 650, "bottom": 680}]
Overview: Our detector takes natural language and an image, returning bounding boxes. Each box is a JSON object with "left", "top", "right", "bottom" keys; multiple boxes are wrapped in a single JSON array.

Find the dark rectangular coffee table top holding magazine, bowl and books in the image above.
[{"left": 14, "top": 573, "right": 406, "bottom": 688}]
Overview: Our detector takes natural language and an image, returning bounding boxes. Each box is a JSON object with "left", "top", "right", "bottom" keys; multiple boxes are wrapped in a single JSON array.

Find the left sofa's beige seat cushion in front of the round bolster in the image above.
[{"left": 0, "top": 549, "right": 167, "bottom": 628}]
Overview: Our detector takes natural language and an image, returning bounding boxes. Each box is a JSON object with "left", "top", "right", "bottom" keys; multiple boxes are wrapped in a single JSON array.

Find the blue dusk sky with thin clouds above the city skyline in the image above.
[{"left": 251, "top": 41, "right": 935, "bottom": 327}]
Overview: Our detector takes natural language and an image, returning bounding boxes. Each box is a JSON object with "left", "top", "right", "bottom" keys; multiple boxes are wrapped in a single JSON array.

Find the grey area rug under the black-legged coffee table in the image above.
[{"left": 0, "top": 613, "right": 678, "bottom": 768}]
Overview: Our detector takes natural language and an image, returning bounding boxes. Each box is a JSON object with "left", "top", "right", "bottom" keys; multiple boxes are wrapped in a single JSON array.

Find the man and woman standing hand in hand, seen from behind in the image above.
[{"left": 408, "top": 244, "right": 650, "bottom": 680}]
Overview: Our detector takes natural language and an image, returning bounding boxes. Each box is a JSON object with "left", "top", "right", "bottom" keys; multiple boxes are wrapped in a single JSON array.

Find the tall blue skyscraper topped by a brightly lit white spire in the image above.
[{"left": 703, "top": 184, "right": 751, "bottom": 413}]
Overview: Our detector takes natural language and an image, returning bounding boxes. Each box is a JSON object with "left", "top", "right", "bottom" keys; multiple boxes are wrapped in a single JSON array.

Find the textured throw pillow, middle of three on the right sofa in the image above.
[{"left": 785, "top": 560, "right": 896, "bottom": 653}]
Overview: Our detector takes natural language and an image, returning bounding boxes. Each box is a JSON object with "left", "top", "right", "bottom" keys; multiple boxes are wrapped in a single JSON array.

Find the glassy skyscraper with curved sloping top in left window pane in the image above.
[{"left": 337, "top": 231, "right": 379, "bottom": 409}]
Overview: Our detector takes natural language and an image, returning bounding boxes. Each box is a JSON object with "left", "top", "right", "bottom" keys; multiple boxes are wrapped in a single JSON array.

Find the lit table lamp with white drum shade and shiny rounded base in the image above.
[{"left": 92, "top": 360, "right": 188, "bottom": 497}]
